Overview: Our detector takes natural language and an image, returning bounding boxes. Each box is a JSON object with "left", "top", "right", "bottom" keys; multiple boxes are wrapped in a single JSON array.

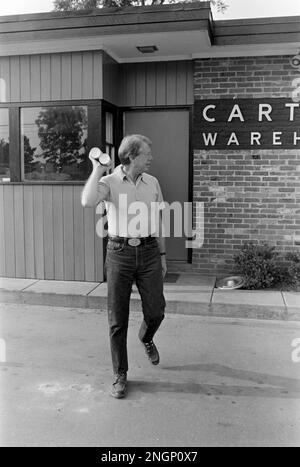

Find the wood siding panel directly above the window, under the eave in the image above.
[{"left": 0, "top": 51, "right": 103, "bottom": 103}]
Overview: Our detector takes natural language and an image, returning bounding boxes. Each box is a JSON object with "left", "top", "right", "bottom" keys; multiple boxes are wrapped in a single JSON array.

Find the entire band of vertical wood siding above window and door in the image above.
[{"left": 0, "top": 51, "right": 193, "bottom": 107}]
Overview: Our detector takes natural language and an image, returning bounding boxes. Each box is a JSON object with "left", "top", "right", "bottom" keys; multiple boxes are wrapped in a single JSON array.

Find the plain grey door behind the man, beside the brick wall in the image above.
[{"left": 124, "top": 110, "right": 189, "bottom": 262}]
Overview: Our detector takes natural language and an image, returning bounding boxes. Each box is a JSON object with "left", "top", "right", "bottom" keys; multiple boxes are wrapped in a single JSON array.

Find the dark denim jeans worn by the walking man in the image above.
[{"left": 106, "top": 238, "right": 165, "bottom": 374}]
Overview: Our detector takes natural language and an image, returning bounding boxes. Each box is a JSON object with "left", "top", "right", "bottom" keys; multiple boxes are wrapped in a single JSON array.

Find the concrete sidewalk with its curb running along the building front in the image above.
[{"left": 0, "top": 273, "right": 300, "bottom": 321}]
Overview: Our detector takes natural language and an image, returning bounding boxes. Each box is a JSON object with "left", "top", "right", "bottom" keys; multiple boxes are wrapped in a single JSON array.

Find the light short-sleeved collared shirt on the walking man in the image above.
[{"left": 99, "top": 165, "right": 164, "bottom": 237}]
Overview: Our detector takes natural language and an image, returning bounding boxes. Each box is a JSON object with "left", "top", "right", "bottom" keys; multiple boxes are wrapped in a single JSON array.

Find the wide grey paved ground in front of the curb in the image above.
[{"left": 0, "top": 304, "right": 300, "bottom": 447}]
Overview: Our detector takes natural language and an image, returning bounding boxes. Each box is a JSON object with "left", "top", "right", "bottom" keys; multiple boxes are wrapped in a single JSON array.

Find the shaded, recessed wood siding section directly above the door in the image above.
[{"left": 119, "top": 61, "right": 194, "bottom": 107}]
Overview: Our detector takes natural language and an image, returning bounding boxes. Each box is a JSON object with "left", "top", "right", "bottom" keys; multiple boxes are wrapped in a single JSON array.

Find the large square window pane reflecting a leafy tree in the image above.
[{"left": 21, "top": 105, "right": 89, "bottom": 181}]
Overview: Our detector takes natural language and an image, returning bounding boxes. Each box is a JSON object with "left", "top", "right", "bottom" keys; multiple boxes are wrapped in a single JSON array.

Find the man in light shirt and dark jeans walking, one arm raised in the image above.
[{"left": 81, "top": 135, "right": 167, "bottom": 398}]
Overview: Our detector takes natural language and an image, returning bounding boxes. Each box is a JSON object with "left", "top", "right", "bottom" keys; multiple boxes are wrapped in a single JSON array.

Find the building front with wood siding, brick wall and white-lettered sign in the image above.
[{"left": 0, "top": 2, "right": 300, "bottom": 281}]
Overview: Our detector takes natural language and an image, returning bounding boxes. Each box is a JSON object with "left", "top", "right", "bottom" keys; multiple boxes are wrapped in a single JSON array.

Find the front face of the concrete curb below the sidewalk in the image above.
[{"left": 0, "top": 290, "right": 300, "bottom": 321}]
